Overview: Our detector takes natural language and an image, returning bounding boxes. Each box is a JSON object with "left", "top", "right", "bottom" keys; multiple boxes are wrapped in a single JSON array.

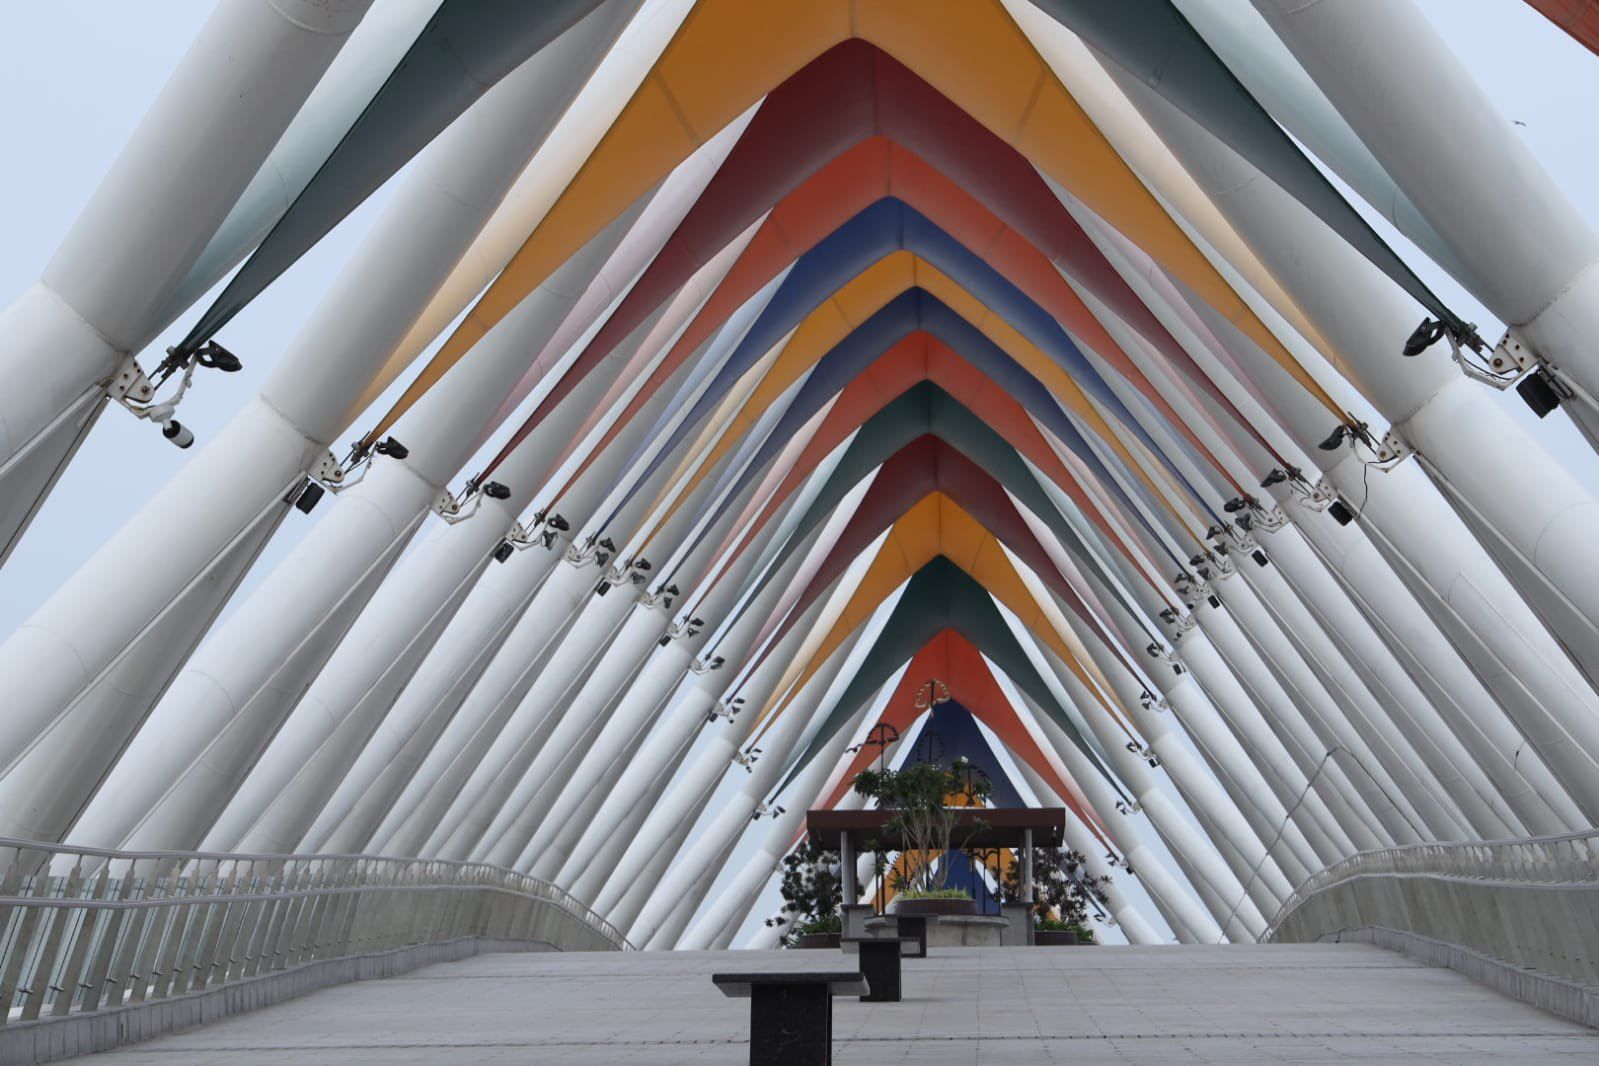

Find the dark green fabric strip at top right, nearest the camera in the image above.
[{"left": 1033, "top": 0, "right": 1465, "bottom": 336}]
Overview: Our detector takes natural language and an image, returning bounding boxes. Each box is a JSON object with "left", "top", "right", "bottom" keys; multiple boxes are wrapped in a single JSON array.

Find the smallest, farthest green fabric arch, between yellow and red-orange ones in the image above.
[{"left": 772, "top": 555, "right": 1130, "bottom": 802}]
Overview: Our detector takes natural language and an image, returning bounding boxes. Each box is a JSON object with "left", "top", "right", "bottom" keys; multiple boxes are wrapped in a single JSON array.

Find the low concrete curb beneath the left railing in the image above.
[{"left": 0, "top": 937, "right": 556, "bottom": 1066}]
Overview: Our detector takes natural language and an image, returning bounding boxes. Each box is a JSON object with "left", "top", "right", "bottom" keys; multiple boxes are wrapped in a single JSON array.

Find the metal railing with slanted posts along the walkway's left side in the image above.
[{"left": 0, "top": 837, "right": 632, "bottom": 1026}]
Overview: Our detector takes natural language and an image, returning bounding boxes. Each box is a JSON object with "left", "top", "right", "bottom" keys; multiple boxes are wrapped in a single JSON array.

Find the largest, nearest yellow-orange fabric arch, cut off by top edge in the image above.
[{"left": 368, "top": 0, "right": 1343, "bottom": 440}]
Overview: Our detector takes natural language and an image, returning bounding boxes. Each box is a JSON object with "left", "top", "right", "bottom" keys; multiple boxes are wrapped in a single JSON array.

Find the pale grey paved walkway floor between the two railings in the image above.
[{"left": 77, "top": 945, "right": 1599, "bottom": 1066}]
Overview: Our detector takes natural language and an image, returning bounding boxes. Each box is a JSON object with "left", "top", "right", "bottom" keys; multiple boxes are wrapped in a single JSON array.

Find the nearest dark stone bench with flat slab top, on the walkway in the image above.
[{"left": 710, "top": 972, "right": 871, "bottom": 1066}]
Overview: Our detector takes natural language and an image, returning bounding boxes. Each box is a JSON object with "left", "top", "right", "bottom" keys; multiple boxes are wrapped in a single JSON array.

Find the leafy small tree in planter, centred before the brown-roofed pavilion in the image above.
[{"left": 854, "top": 759, "right": 993, "bottom": 916}]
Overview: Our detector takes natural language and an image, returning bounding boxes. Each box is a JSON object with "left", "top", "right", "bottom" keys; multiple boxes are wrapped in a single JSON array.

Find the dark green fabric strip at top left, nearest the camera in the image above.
[{"left": 179, "top": 0, "right": 604, "bottom": 352}]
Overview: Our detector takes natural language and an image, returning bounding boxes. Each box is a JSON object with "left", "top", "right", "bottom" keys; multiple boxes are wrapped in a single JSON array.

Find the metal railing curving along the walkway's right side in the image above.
[{"left": 1263, "top": 829, "right": 1599, "bottom": 984}]
